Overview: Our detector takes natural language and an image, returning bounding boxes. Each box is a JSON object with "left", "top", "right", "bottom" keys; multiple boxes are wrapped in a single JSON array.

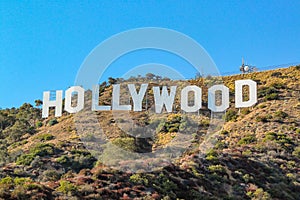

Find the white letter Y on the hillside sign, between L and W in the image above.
[{"left": 128, "top": 84, "right": 148, "bottom": 111}]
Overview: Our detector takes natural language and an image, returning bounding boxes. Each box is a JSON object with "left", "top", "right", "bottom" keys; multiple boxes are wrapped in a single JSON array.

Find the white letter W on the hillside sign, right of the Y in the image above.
[{"left": 153, "top": 86, "right": 177, "bottom": 113}]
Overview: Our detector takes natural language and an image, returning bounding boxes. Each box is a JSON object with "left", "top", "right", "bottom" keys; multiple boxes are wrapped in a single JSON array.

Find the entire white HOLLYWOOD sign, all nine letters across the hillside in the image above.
[{"left": 42, "top": 79, "right": 257, "bottom": 118}]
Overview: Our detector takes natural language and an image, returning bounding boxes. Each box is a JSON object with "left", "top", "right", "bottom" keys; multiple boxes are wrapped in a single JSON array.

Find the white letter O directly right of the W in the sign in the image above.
[{"left": 180, "top": 85, "right": 202, "bottom": 112}]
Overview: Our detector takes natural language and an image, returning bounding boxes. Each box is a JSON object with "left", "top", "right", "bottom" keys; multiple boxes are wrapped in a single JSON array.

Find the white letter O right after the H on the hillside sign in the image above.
[{"left": 65, "top": 86, "right": 84, "bottom": 113}]
